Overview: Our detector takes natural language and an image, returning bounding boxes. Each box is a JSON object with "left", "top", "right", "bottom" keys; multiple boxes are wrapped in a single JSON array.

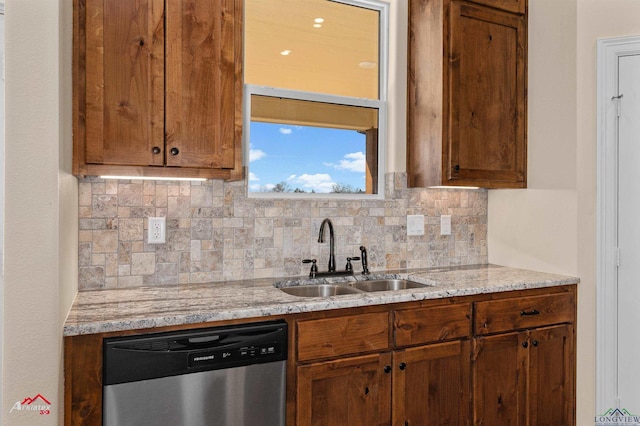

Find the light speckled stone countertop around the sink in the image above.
[{"left": 64, "top": 265, "right": 580, "bottom": 336}]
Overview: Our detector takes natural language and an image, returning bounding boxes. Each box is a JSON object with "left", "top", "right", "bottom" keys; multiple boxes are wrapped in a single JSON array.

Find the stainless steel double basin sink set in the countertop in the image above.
[{"left": 280, "top": 279, "right": 428, "bottom": 297}]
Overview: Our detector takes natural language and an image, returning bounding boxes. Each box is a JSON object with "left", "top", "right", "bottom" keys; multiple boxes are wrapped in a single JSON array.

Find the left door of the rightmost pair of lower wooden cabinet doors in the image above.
[{"left": 472, "top": 331, "right": 529, "bottom": 426}]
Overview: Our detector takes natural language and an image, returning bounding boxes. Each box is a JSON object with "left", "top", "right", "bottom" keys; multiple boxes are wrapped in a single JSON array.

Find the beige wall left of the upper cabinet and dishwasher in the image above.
[{"left": 0, "top": 0, "right": 77, "bottom": 426}]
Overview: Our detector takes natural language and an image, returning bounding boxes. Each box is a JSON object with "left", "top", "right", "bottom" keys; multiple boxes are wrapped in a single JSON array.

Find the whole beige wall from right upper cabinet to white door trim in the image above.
[{"left": 488, "top": 0, "right": 640, "bottom": 425}]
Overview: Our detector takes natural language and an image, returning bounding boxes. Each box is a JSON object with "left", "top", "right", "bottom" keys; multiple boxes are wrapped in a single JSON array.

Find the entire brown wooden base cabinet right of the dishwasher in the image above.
[{"left": 290, "top": 286, "right": 576, "bottom": 426}]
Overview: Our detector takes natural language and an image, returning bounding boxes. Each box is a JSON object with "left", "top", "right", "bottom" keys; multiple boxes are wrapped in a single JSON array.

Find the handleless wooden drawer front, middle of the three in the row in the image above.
[{"left": 394, "top": 303, "right": 471, "bottom": 346}]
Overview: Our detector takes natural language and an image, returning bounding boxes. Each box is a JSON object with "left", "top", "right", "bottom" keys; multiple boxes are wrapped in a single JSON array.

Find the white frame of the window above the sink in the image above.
[{"left": 242, "top": 0, "right": 389, "bottom": 199}]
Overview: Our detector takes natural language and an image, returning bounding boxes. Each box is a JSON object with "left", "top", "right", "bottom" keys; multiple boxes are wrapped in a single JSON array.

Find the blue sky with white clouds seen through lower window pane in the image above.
[{"left": 249, "top": 122, "right": 366, "bottom": 193}]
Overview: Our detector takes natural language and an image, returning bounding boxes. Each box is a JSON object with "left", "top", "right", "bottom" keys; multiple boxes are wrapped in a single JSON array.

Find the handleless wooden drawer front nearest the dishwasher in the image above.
[{"left": 297, "top": 312, "right": 389, "bottom": 361}]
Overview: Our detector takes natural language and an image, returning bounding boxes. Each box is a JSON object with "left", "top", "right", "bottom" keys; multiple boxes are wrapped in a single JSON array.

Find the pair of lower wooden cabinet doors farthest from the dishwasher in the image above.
[{"left": 472, "top": 324, "right": 575, "bottom": 426}]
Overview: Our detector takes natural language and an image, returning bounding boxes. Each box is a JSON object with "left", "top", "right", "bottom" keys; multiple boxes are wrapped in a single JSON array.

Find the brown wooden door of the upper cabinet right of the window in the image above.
[{"left": 443, "top": 2, "right": 527, "bottom": 187}]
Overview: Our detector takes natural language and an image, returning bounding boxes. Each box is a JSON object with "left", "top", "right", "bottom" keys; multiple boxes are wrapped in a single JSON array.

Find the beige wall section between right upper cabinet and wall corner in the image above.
[{"left": 489, "top": 0, "right": 577, "bottom": 274}]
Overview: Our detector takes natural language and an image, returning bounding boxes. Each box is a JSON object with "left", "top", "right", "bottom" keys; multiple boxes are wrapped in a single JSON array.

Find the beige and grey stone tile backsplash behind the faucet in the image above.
[{"left": 78, "top": 173, "right": 488, "bottom": 291}]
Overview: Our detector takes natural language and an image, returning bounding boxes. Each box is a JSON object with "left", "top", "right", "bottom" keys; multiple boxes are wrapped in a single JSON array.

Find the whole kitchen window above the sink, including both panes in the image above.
[{"left": 243, "top": 0, "right": 388, "bottom": 197}]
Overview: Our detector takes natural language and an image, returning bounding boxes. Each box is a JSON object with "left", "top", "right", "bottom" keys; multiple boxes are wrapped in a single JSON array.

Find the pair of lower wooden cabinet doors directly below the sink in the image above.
[{"left": 296, "top": 340, "right": 470, "bottom": 426}]
